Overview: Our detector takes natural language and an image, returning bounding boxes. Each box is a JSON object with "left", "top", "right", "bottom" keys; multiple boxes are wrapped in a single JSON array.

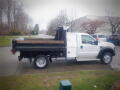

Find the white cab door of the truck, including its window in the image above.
[{"left": 77, "top": 34, "right": 100, "bottom": 61}]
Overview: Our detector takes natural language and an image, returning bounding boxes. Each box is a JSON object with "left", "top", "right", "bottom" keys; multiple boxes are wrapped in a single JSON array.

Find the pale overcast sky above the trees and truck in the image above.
[{"left": 23, "top": 0, "right": 120, "bottom": 29}]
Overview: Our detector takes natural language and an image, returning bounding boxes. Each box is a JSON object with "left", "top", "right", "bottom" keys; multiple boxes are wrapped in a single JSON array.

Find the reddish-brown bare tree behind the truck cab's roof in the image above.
[{"left": 81, "top": 20, "right": 105, "bottom": 34}]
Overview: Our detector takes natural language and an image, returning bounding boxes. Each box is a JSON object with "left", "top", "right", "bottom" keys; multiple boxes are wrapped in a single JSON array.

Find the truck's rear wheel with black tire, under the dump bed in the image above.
[{"left": 34, "top": 56, "right": 49, "bottom": 69}]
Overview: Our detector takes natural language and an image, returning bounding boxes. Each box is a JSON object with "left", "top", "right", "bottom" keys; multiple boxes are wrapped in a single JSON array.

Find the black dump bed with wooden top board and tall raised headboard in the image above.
[{"left": 12, "top": 29, "right": 66, "bottom": 51}]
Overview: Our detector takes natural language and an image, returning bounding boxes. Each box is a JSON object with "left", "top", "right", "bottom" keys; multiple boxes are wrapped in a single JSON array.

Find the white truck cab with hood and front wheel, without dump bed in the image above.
[{"left": 66, "top": 32, "right": 115, "bottom": 64}]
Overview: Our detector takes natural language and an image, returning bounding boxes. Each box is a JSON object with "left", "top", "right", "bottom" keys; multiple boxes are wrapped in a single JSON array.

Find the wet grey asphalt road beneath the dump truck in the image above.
[{"left": 0, "top": 47, "right": 120, "bottom": 76}]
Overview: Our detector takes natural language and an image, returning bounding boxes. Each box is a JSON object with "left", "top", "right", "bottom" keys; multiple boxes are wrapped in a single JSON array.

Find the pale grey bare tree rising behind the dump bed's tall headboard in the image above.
[{"left": 47, "top": 11, "right": 69, "bottom": 35}]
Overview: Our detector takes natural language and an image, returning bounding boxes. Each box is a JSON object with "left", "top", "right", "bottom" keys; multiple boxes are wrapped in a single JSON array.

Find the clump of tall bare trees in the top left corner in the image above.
[{"left": 0, "top": 0, "right": 30, "bottom": 32}]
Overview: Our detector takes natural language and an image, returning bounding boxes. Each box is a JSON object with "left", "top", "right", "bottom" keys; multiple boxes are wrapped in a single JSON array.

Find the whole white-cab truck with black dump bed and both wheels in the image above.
[{"left": 11, "top": 29, "right": 115, "bottom": 69}]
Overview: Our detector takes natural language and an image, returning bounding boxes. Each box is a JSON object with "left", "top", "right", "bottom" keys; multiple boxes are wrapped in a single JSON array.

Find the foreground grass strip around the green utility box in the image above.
[{"left": 0, "top": 71, "right": 120, "bottom": 90}]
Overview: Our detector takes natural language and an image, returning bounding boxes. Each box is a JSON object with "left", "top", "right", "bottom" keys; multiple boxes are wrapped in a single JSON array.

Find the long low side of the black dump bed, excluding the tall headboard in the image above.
[{"left": 12, "top": 40, "right": 65, "bottom": 51}]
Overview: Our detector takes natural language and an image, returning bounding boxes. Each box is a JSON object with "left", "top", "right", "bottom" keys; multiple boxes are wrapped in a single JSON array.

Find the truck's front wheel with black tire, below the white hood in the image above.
[{"left": 101, "top": 52, "right": 112, "bottom": 64}]
